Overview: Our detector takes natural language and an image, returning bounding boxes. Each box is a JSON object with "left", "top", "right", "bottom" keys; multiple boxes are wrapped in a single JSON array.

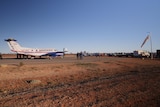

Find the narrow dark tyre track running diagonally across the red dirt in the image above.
[{"left": 0, "top": 71, "right": 144, "bottom": 98}]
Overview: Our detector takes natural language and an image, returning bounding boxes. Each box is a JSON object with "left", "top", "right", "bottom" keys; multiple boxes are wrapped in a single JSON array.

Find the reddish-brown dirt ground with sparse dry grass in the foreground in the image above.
[{"left": 0, "top": 57, "right": 160, "bottom": 107}]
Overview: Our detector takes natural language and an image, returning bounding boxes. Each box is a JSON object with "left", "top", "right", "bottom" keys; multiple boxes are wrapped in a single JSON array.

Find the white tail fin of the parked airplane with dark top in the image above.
[{"left": 5, "top": 39, "right": 22, "bottom": 52}]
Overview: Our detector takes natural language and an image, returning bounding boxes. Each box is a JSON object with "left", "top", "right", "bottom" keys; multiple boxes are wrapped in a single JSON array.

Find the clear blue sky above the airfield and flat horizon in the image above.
[{"left": 0, "top": 0, "right": 160, "bottom": 53}]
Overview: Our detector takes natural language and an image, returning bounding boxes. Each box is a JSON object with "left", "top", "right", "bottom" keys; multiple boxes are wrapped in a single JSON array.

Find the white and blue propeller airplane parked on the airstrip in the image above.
[{"left": 5, "top": 39, "right": 67, "bottom": 58}]
